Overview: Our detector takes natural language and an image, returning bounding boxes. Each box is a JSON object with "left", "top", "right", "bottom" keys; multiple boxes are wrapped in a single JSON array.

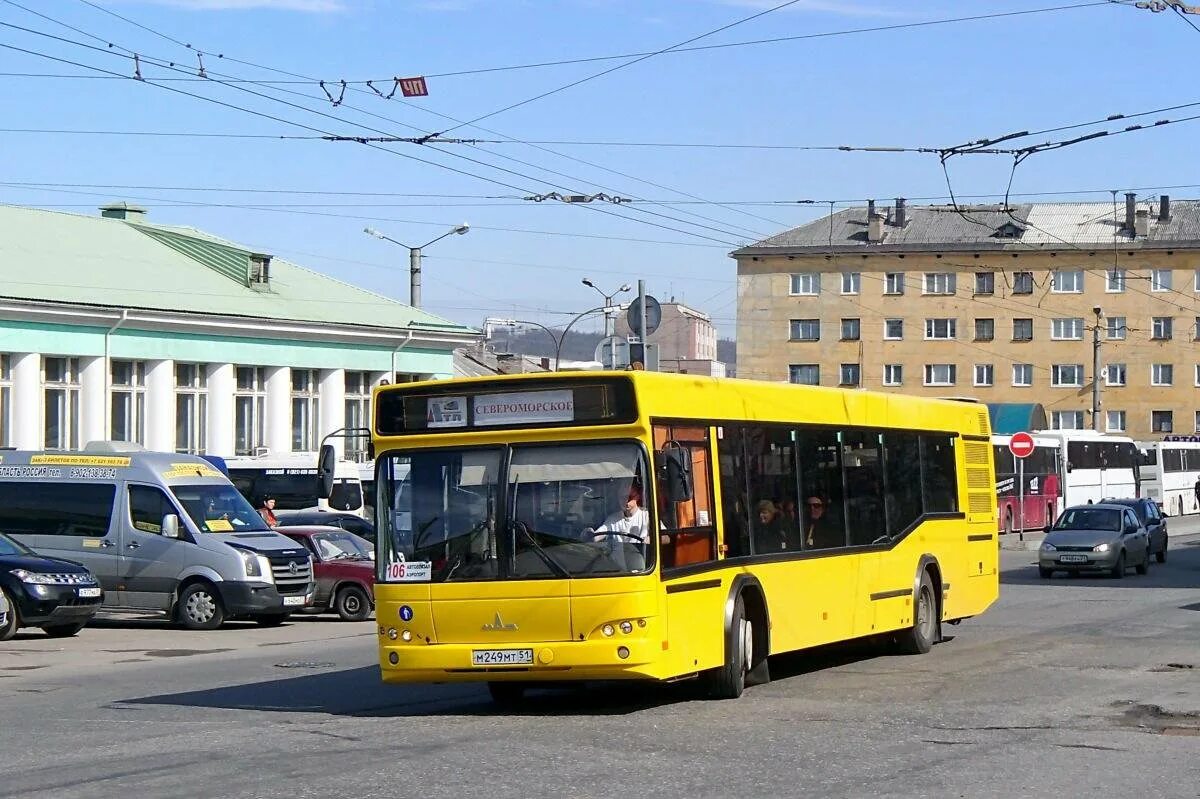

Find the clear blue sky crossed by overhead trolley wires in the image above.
[{"left": 0, "top": 0, "right": 1200, "bottom": 335}]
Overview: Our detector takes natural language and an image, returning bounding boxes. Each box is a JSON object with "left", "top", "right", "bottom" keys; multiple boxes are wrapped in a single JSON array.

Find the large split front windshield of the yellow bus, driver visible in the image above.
[{"left": 377, "top": 441, "right": 656, "bottom": 582}]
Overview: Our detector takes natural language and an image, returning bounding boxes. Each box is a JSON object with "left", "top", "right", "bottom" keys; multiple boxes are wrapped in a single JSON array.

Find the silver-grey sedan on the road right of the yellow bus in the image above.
[{"left": 1038, "top": 504, "right": 1151, "bottom": 578}]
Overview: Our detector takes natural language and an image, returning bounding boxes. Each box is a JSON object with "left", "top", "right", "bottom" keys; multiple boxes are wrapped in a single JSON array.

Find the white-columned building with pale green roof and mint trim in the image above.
[{"left": 0, "top": 203, "right": 479, "bottom": 456}]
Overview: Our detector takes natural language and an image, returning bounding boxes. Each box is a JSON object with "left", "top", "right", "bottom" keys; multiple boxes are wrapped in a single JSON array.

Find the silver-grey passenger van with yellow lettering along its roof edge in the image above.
[{"left": 0, "top": 450, "right": 316, "bottom": 630}]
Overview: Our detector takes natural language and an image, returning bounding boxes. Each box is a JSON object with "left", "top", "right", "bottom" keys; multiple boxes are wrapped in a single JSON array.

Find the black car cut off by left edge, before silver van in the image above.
[{"left": 0, "top": 533, "right": 104, "bottom": 641}]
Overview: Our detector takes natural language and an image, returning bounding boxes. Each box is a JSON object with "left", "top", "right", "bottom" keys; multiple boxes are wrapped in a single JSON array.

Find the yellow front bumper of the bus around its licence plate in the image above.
[{"left": 379, "top": 633, "right": 662, "bottom": 683}]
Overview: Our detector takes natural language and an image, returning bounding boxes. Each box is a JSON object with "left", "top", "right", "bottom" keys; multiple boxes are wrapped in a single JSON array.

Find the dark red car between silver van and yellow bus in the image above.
[{"left": 276, "top": 525, "right": 374, "bottom": 621}]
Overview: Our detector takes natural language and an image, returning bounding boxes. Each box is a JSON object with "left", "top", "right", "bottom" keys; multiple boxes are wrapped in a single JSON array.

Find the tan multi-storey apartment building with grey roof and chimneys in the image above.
[{"left": 732, "top": 194, "right": 1200, "bottom": 438}]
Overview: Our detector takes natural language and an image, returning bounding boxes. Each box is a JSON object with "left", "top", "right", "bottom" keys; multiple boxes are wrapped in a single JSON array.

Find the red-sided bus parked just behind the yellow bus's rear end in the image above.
[{"left": 991, "top": 434, "right": 1060, "bottom": 534}]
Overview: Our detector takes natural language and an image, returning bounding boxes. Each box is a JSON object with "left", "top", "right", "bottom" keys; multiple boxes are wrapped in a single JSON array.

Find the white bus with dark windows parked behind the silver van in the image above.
[{"left": 224, "top": 453, "right": 366, "bottom": 518}]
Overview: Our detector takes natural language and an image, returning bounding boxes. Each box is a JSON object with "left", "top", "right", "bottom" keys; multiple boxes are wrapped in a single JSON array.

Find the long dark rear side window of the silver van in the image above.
[{"left": 0, "top": 481, "right": 116, "bottom": 537}]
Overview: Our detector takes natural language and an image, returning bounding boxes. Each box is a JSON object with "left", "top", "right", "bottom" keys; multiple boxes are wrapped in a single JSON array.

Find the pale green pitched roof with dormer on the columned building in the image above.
[{"left": 0, "top": 204, "right": 473, "bottom": 334}]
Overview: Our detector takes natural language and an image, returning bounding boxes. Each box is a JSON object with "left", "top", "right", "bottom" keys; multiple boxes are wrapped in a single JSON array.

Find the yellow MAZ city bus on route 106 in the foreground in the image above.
[{"left": 352, "top": 372, "right": 998, "bottom": 702}]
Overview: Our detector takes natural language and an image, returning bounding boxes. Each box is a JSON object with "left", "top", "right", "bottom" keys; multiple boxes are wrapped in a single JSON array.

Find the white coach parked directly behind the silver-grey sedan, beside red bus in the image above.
[{"left": 1037, "top": 429, "right": 1141, "bottom": 510}]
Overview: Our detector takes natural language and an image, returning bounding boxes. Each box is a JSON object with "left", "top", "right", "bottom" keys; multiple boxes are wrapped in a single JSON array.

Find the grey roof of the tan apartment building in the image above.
[{"left": 733, "top": 199, "right": 1200, "bottom": 257}]
